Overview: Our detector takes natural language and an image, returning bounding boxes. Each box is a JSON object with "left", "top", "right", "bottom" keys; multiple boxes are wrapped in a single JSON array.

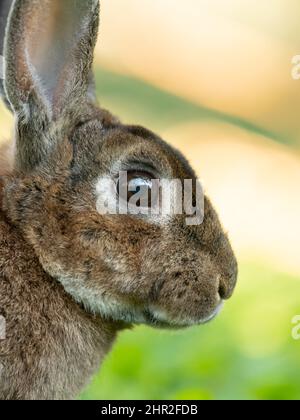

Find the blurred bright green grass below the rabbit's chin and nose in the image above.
[{"left": 81, "top": 263, "right": 300, "bottom": 400}]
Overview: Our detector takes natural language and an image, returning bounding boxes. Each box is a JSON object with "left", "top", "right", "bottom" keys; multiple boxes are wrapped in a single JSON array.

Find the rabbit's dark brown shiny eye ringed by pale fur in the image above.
[{"left": 117, "top": 171, "right": 159, "bottom": 209}]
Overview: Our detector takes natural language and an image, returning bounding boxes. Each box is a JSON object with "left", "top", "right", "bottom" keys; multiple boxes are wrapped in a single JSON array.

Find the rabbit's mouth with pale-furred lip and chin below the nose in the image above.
[{"left": 143, "top": 300, "right": 224, "bottom": 329}]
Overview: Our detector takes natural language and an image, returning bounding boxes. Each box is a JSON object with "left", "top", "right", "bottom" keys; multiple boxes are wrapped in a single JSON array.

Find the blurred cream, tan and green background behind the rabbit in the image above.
[{"left": 0, "top": 0, "right": 300, "bottom": 399}]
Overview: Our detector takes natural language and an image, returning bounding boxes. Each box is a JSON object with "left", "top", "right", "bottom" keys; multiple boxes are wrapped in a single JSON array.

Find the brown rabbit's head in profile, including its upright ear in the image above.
[{"left": 4, "top": 0, "right": 237, "bottom": 328}]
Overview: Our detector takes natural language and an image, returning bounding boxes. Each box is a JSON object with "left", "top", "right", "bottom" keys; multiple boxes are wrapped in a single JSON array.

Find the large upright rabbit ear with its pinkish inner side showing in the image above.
[{"left": 4, "top": 0, "right": 99, "bottom": 169}]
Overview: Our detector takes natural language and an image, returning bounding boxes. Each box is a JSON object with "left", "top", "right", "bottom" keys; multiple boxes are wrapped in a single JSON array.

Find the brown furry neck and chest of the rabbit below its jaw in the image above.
[{"left": 0, "top": 211, "right": 120, "bottom": 399}]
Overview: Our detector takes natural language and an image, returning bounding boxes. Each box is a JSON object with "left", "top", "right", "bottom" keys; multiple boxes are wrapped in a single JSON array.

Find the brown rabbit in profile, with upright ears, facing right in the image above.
[{"left": 0, "top": 0, "right": 238, "bottom": 400}]
